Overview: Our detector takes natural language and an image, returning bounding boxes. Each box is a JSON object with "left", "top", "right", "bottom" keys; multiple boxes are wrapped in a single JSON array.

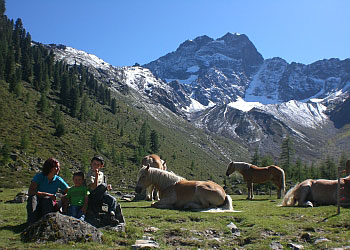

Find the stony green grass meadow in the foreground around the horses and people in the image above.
[{"left": 0, "top": 189, "right": 350, "bottom": 249}]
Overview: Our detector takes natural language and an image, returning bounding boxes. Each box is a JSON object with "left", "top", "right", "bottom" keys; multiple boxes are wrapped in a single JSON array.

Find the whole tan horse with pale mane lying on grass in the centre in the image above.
[{"left": 135, "top": 166, "right": 233, "bottom": 211}]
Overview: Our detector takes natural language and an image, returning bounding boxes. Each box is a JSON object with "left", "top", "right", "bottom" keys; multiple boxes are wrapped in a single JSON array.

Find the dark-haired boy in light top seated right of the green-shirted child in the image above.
[{"left": 86, "top": 156, "right": 124, "bottom": 223}]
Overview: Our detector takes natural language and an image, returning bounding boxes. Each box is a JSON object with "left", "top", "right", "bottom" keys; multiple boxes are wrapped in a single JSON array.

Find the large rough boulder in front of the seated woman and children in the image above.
[{"left": 21, "top": 213, "right": 102, "bottom": 243}]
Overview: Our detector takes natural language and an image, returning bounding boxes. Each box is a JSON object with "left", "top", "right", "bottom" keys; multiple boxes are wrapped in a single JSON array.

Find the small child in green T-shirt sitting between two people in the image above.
[{"left": 67, "top": 172, "right": 89, "bottom": 220}]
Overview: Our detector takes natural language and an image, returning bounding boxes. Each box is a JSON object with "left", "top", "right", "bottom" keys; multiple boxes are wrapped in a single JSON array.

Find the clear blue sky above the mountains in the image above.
[{"left": 5, "top": 0, "right": 350, "bottom": 66}]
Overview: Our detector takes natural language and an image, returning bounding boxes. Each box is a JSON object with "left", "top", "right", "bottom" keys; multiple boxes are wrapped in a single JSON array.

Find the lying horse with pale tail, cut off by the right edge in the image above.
[{"left": 281, "top": 177, "right": 350, "bottom": 207}]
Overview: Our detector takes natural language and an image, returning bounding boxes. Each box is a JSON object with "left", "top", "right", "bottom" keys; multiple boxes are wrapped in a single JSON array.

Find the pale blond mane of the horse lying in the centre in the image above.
[{"left": 140, "top": 166, "right": 185, "bottom": 189}]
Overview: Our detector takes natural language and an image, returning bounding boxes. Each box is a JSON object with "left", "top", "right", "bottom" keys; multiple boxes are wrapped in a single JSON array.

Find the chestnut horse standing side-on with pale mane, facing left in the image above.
[{"left": 226, "top": 162, "right": 286, "bottom": 200}]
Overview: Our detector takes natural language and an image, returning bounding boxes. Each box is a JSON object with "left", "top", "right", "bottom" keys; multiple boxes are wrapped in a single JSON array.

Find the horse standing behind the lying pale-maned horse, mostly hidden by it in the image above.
[{"left": 141, "top": 154, "right": 167, "bottom": 201}]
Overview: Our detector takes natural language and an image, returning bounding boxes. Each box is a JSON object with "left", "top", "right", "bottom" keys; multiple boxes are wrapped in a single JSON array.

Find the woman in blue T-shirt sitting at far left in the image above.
[{"left": 27, "top": 158, "right": 69, "bottom": 225}]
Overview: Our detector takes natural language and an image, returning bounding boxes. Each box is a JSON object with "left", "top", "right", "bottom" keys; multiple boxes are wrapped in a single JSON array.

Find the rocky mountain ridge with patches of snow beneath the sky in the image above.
[{"left": 43, "top": 33, "right": 350, "bottom": 158}]
